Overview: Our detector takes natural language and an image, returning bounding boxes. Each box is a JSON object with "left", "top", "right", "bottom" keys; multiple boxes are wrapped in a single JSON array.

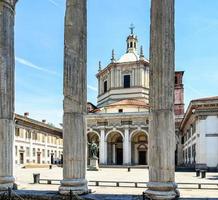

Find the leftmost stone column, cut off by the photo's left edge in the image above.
[{"left": 0, "top": 0, "right": 17, "bottom": 190}]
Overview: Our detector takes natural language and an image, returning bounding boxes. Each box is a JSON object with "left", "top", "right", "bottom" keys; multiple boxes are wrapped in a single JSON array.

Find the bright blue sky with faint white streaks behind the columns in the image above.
[{"left": 15, "top": 0, "right": 218, "bottom": 125}]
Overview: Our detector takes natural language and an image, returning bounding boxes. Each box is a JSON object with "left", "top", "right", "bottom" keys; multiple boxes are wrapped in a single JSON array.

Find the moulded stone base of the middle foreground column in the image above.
[{"left": 59, "top": 179, "right": 89, "bottom": 195}]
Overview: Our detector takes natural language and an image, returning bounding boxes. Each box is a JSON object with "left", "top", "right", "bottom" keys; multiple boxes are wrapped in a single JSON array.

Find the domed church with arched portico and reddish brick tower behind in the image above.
[{"left": 87, "top": 29, "right": 184, "bottom": 165}]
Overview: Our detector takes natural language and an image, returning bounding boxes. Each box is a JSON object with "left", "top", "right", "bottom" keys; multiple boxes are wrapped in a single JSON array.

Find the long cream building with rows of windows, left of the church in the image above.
[{"left": 14, "top": 113, "right": 63, "bottom": 165}]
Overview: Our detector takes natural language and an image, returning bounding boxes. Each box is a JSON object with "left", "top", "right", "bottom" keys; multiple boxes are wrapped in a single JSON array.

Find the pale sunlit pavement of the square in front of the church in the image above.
[{"left": 15, "top": 167, "right": 218, "bottom": 200}]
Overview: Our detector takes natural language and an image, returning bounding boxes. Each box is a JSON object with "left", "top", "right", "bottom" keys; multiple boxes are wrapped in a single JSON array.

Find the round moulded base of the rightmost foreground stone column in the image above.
[{"left": 145, "top": 182, "right": 180, "bottom": 200}]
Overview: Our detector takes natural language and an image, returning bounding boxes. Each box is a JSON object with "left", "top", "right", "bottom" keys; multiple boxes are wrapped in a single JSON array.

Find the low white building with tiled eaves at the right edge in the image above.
[{"left": 180, "top": 97, "right": 218, "bottom": 169}]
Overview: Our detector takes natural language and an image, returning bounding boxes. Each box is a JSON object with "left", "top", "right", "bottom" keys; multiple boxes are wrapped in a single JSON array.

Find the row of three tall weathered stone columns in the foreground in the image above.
[{"left": 0, "top": 0, "right": 178, "bottom": 199}]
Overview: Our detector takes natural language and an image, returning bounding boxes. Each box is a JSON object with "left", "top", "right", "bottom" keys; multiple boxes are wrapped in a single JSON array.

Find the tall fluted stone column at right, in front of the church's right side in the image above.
[{"left": 146, "top": 0, "right": 178, "bottom": 200}]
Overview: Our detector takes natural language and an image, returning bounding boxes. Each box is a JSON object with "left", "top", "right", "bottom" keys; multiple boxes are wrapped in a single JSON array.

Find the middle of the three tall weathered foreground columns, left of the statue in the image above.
[{"left": 59, "top": 0, "right": 88, "bottom": 194}]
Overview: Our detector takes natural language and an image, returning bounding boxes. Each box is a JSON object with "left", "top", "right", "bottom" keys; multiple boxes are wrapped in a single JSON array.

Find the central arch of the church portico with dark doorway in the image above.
[{"left": 106, "top": 131, "right": 123, "bottom": 165}]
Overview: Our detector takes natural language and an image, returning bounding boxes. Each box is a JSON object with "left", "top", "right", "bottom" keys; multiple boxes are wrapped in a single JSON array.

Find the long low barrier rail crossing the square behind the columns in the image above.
[{"left": 39, "top": 179, "right": 218, "bottom": 190}]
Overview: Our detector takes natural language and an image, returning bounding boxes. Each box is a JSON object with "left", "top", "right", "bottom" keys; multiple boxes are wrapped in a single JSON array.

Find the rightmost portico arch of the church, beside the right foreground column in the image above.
[{"left": 131, "top": 131, "right": 148, "bottom": 165}]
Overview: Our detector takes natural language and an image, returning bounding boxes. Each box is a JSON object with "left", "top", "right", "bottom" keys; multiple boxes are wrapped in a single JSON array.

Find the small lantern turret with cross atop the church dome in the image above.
[{"left": 126, "top": 24, "right": 138, "bottom": 53}]
